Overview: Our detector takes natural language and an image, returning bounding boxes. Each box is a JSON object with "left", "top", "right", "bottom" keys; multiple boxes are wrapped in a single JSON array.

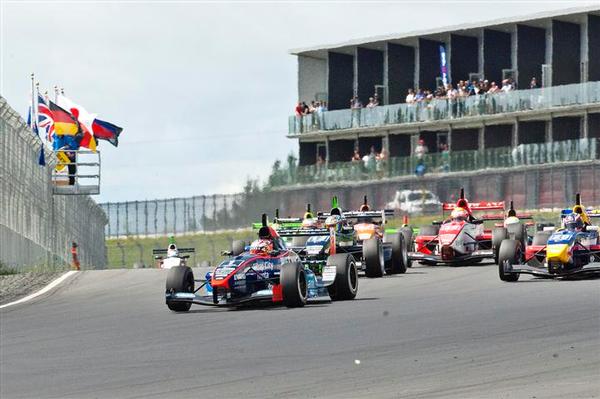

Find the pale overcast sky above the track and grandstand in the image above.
[{"left": 0, "top": 0, "right": 597, "bottom": 202}]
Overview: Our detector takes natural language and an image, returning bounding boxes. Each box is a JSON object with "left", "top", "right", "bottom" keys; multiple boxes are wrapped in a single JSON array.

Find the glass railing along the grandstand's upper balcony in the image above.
[{"left": 288, "top": 82, "right": 600, "bottom": 134}]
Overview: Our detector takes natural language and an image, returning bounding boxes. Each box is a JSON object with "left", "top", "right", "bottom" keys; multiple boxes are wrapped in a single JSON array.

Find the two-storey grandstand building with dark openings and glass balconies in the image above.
[{"left": 275, "top": 7, "right": 600, "bottom": 209}]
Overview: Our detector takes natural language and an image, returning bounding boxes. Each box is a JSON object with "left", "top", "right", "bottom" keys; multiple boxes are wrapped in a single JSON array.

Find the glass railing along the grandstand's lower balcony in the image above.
[{"left": 269, "top": 138, "right": 600, "bottom": 186}]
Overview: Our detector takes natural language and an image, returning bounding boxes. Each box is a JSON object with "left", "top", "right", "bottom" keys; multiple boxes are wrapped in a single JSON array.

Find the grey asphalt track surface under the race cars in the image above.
[{"left": 0, "top": 265, "right": 600, "bottom": 399}]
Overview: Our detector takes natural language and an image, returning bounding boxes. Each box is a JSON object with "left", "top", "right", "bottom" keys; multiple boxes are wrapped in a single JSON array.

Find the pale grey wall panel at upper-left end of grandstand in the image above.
[{"left": 298, "top": 56, "right": 327, "bottom": 104}]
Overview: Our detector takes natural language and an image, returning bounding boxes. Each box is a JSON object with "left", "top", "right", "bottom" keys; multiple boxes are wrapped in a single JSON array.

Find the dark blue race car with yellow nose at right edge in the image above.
[{"left": 498, "top": 194, "right": 600, "bottom": 282}]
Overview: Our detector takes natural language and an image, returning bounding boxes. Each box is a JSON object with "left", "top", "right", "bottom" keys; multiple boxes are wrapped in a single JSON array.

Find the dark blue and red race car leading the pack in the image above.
[{"left": 165, "top": 215, "right": 358, "bottom": 312}]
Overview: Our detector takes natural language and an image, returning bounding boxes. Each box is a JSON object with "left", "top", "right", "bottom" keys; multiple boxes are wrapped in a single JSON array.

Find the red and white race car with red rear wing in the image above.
[{"left": 408, "top": 188, "right": 504, "bottom": 265}]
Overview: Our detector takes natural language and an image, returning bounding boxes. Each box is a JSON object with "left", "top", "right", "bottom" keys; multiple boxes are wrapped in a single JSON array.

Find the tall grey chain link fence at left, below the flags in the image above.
[{"left": 0, "top": 97, "right": 107, "bottom": 269}]
